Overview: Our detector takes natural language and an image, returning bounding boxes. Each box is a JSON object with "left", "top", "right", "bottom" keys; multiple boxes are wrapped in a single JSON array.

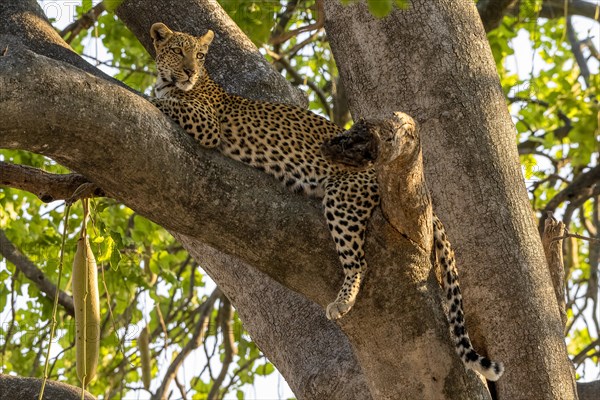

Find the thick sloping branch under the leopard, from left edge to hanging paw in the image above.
[{"left": 0, "top": 44, "right": 338, "bottom": 310}]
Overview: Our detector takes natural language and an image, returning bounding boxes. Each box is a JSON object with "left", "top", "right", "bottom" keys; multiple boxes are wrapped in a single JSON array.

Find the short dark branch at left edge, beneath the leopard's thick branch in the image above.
[{"left": 0, "top": 161, "right": 104, "bottom": 203}]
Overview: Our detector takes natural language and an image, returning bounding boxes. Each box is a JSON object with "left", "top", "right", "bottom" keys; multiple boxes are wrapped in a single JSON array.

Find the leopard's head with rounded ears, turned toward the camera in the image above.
[{"left": 150, "top": 22, "right": 215, "bottom": 91}]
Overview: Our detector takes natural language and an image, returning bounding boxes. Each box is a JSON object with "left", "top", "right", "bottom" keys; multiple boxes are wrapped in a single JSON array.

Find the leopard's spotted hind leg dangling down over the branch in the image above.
[{"left": 323, "top": 171, "right": 379, "bottom": 320}]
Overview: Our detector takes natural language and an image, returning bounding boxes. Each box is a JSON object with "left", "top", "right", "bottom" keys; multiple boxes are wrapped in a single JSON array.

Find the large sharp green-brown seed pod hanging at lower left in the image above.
[{"left": 72, "top": 233, "right": 100, "bottom": 387}]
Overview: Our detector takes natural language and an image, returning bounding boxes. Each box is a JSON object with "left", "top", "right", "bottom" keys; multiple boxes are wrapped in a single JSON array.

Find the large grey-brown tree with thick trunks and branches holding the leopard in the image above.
[{"left": 0, "top": 1, "right": 596, "bottom": 399}]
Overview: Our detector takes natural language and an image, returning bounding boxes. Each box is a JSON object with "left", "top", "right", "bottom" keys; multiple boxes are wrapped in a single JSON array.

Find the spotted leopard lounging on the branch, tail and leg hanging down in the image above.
[{"left": 150, "top": 23, "right": 504, "bottom": 381}]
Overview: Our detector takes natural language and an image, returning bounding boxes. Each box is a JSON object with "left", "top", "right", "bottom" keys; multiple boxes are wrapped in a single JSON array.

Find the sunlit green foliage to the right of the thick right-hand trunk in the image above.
[{"left": 488, "top": 7, "right": 600, "bottom": 376}]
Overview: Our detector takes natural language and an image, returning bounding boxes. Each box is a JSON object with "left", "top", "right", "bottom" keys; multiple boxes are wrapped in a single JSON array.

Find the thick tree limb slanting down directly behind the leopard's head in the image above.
[{"left": 115, "top": 0, "right": 307, "bottom": 106}]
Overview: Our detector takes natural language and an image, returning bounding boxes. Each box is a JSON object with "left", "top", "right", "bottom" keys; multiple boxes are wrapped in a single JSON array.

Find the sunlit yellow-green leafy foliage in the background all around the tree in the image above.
[{"left": 0, "top": 0, "right": 600, "bottom": 399}]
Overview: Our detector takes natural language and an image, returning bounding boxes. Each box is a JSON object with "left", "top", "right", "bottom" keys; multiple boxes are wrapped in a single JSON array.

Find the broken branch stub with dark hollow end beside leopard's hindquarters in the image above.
[{"left": 322, "top": 112, "right": 433, "bottom": 252}]
